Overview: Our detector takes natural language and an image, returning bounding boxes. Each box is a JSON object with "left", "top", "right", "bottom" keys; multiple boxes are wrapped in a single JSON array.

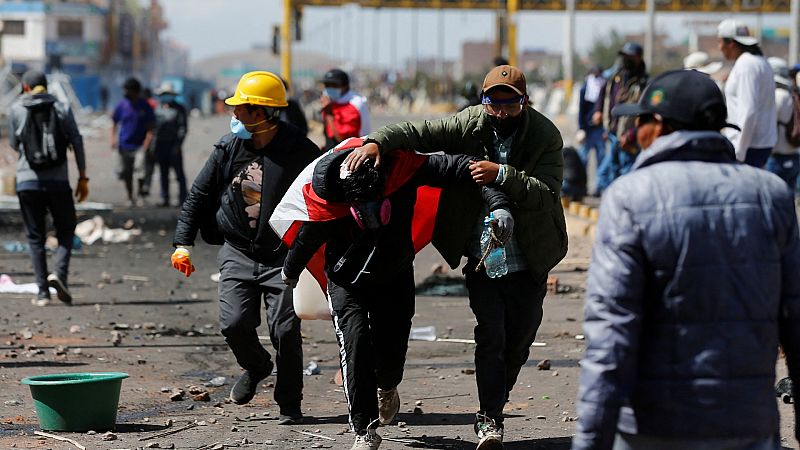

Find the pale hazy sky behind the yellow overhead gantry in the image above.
[{"left": 162, "top": 0, "right": 789, "bottom": 67}]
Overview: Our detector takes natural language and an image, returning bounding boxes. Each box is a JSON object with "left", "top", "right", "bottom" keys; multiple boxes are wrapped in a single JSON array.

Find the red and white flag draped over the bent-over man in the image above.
[{"left": 269, "top": 138, "right": 441, "bottom": 292}]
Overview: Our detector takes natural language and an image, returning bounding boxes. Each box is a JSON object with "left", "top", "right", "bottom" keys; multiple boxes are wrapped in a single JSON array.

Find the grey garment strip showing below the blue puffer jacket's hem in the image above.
[{"left": 613, "top": 433, "right": 781, "bottom": 450}]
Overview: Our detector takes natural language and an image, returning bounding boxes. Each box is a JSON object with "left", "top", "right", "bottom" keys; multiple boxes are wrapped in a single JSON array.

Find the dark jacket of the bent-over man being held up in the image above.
[{"left": 284, "top": 152, "right": 511, "bottom": 287}]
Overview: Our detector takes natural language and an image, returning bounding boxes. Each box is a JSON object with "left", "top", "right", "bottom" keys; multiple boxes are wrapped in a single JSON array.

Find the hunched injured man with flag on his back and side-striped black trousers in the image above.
[{"left": 270, "top": 139, "right": 513, "bottom": 450}]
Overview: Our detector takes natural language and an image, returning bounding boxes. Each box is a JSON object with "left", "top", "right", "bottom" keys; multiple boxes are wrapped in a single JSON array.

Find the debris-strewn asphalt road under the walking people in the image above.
[{"left": 0, "top": 112, "right": 797, "bottom": 450}]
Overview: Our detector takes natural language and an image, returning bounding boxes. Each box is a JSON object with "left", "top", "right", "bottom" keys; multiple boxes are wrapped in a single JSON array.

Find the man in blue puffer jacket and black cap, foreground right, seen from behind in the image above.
[{"left": 572, "top": 70, "right": 800, "bottom": 450}]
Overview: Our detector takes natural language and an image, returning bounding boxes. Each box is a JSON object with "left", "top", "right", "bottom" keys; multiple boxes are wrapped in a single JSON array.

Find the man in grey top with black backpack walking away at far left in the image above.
[{"left": 8, "top": 70, "right": 89, "bottom": 305}]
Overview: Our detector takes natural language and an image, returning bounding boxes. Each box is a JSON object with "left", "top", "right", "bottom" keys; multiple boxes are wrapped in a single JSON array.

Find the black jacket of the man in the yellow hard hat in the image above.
[{"left": 173, "top": 122, "right": 320, "bottom": 265}]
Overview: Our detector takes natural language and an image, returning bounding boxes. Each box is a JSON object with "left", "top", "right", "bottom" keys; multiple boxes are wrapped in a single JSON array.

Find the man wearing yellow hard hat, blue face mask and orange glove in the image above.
[{"left": 172, "top": 71, "right": 320, "bottom": 424}]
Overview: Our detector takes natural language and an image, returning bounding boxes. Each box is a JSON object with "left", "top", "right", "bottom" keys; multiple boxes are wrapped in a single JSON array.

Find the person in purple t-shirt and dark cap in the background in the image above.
[{"left": 111, "top": 78, "right": 156, "bottom": 206}]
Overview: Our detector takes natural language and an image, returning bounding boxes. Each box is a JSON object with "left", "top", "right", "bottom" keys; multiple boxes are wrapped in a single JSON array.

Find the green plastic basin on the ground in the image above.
[{"left": 22, "top": 372, "right": 128, "bottom": 431}]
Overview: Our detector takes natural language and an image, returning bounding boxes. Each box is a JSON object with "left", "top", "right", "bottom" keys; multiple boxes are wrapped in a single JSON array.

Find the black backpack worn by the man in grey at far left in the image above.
[{"left": 19, "top": 102, "right": 67, "bottom": 170}]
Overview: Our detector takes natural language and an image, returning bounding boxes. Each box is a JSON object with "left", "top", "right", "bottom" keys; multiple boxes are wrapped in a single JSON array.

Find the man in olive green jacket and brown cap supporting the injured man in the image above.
[{"left": 347, "top": 65, "right": 567, "bottom": 450}]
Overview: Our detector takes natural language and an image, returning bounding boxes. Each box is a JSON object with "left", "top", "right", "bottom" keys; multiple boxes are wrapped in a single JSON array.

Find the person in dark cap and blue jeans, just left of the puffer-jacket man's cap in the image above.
[{"left": 592, "top": 42, "right": 649, "bottom": 195}]
